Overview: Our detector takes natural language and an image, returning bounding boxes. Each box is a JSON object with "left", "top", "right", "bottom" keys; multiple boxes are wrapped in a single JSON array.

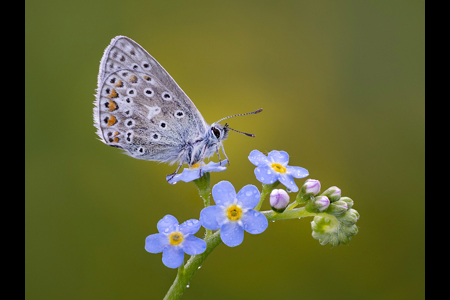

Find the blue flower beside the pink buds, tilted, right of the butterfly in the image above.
[{"left": 248, "top": 150, "right": 309, "bottom": 192}]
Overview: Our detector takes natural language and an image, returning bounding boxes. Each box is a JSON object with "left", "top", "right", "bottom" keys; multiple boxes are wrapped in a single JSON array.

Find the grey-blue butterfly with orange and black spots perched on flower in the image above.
[{"left": 94, "top": 36, "right": 262, "bottom": 180}]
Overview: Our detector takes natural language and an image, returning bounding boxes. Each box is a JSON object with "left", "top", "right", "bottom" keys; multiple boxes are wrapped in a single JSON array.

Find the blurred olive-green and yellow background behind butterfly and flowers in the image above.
[{"left": 25, "top": 0, "right": 425, "bottom": 300}]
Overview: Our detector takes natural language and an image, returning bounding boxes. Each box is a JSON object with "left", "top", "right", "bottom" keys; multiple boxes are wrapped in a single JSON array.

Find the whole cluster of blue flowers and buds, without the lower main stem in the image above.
[{"left": 145, "top": 150, "right": 359, "bottom": 268}]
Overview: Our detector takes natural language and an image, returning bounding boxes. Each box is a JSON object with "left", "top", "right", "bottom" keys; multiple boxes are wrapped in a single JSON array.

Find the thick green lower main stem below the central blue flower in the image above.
[{"left": 164, "top": 230, "right": 222, "bottom": 300}]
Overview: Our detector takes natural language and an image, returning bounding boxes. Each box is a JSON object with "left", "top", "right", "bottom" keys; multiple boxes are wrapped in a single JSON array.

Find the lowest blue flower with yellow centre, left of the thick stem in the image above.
[{"left": 145, "top": 215, "right": 206, "bottom": 269}]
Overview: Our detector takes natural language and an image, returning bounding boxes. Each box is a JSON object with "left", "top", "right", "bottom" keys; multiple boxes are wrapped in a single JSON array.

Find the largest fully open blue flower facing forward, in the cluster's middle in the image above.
[{"left": 200, "top": 181, "right": 268, "bottom": 247}]
